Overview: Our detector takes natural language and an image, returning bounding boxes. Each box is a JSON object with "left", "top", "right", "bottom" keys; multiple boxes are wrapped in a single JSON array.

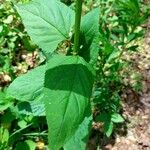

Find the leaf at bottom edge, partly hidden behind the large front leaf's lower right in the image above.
[{"left": 64, "top": 113, "right": 92, "bottom": 150}]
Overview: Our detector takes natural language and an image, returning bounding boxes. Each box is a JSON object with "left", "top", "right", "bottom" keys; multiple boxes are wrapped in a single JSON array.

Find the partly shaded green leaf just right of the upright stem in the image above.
[{"left": 79, "top": 8, "right": 99, "bottom": 63}]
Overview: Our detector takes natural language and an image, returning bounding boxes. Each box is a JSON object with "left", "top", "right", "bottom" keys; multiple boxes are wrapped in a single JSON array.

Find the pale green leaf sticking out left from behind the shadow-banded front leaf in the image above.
[{"left": 7, "top": 65, "right": 45, "bottom": 101}]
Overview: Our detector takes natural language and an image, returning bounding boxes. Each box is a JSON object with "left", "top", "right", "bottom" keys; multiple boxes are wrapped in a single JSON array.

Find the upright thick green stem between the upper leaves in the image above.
[{"left": 73, "top": 0, "right": 82, "bottom": 55}]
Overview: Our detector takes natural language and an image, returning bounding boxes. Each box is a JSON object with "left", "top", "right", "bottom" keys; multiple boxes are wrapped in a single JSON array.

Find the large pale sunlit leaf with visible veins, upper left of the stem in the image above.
[{"left": 16, "top": 0, "right": 74, "bottom": 53}]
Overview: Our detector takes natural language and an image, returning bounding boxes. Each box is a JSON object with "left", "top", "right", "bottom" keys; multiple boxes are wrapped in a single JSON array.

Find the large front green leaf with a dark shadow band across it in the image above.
[{"left": 44, "top": 55, "right": 93, "bottom": 150}]
